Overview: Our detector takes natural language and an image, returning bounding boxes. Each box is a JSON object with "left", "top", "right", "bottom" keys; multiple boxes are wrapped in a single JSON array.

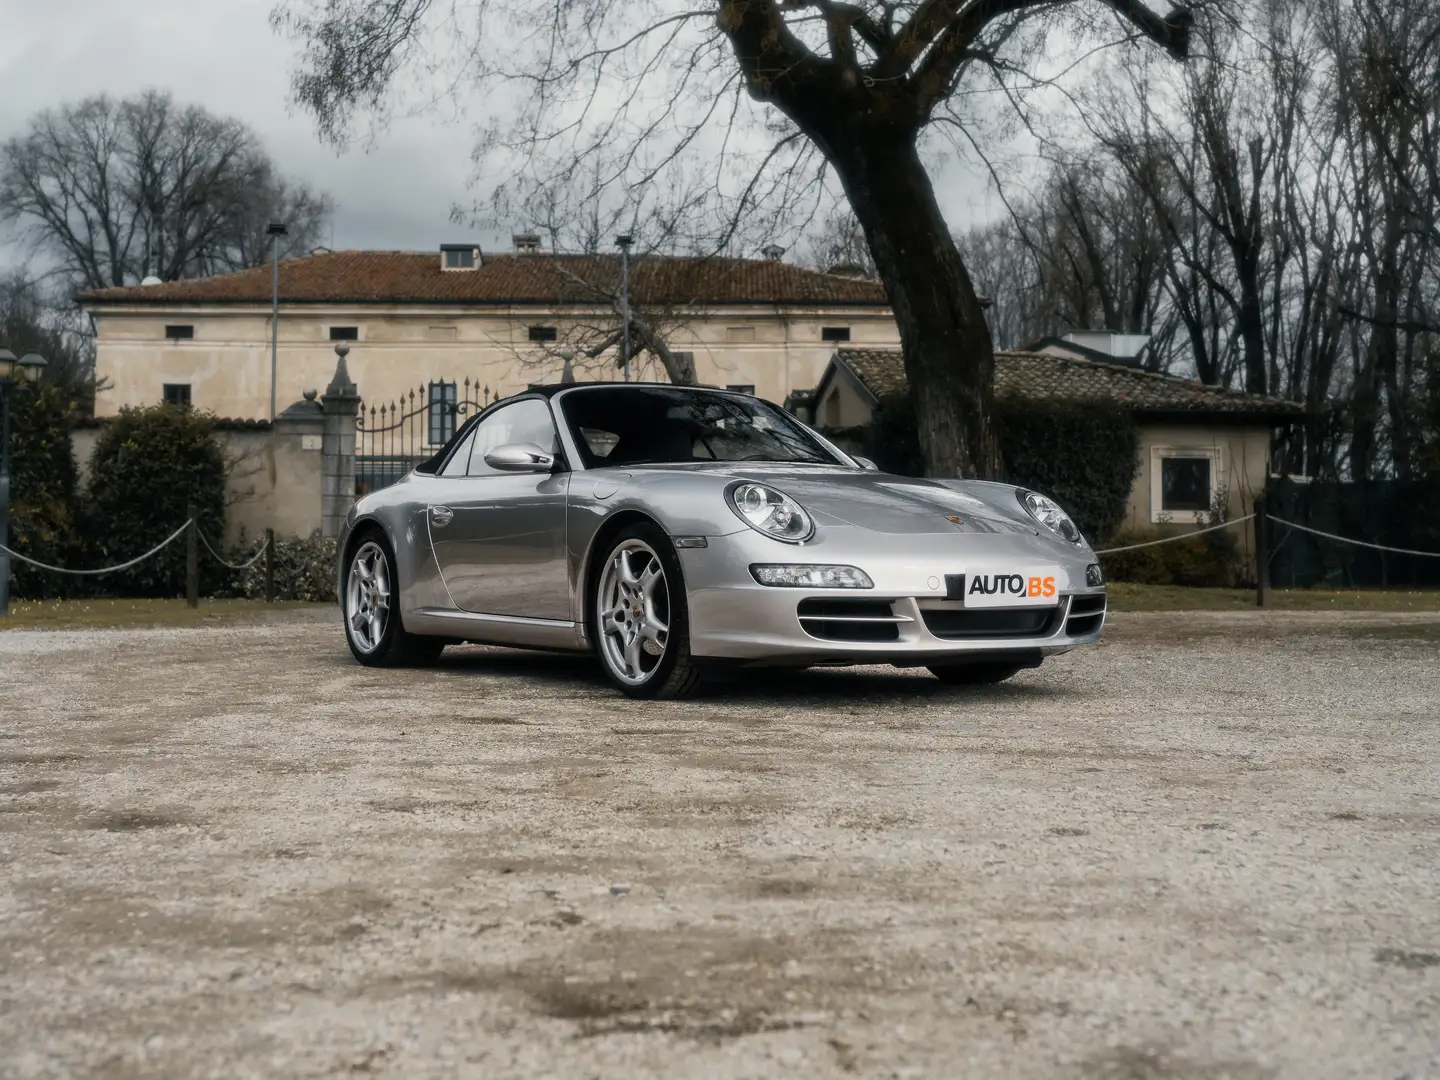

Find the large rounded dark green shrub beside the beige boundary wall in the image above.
[{"left": 85, "top": 405, "right": 230, "bottom": 596}]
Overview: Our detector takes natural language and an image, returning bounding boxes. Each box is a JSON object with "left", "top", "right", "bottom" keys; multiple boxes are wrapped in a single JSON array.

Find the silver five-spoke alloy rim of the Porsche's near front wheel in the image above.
[{"left": 598, "top": 539, "right": 670, "bottom": 685}]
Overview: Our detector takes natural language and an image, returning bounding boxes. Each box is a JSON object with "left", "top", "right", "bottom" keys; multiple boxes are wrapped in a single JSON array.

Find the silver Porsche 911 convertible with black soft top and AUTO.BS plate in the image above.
[{"left": 338, "top": 383, "right": 1106, "bottom": 698}]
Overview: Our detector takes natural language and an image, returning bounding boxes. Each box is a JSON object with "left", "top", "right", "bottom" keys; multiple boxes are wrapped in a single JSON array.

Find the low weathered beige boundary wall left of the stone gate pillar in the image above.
[{"left": 71, "top": 409, "right": 323, "bottom": 546}]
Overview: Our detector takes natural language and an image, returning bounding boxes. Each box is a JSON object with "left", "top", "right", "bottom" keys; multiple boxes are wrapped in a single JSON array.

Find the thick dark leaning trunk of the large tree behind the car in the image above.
[{"left": 825, "top": 127, "right": 1001, "bottom": 480}]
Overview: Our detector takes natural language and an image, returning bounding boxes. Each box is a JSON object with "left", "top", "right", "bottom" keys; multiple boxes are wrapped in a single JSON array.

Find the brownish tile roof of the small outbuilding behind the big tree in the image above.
[{"left": 835, "top": 348, "right": 1305, "bottom": 418}]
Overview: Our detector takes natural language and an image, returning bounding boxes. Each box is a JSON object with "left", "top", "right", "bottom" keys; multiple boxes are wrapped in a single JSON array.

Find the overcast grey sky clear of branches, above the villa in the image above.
[{"left": 0, "top": 0, "right": 988, "bottom": 265}]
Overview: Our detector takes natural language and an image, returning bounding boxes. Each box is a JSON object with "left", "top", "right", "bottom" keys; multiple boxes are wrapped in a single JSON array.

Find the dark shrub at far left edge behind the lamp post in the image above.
[{"left": 9, "top": 380, "right": 84, "bottom": 599}]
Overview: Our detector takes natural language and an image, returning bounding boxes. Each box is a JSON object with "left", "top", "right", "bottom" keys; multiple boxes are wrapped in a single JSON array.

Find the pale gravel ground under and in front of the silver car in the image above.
[{"left": 0, "top": 612, "right": 1440, "bottom": 1080}]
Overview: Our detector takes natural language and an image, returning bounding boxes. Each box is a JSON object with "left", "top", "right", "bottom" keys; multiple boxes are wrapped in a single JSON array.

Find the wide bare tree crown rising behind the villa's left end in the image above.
[{"left": 0, "top": 92, "right": 333, "bottom": 288}]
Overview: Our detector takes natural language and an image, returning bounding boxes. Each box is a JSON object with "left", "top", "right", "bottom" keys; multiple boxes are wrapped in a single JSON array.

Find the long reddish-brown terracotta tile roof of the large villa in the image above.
[{"left": 79, "top": 251, "right": 886, "bottom": 307}]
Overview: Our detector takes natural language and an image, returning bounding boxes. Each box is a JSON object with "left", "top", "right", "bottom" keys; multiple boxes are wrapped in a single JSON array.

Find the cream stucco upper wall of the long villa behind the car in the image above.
[{"left": 94, "top": 305, "right": 900, "bottom": 419}]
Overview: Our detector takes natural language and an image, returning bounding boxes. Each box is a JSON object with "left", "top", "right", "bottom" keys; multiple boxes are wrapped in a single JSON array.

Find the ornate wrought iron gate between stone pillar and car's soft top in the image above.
[{"left": 356, "top": 379, "right": 500, "bottom": 498}]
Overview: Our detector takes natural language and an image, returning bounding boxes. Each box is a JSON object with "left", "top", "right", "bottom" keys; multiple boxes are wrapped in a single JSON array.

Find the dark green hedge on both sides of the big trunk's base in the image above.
[{"left": 861, "top": 397, "right": 1139, "bottom": 541}]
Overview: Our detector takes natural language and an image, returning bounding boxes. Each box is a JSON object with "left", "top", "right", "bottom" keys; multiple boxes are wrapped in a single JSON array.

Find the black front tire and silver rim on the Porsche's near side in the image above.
[{"left": 590, "top": 523, "right": 700, "bottom": 700}]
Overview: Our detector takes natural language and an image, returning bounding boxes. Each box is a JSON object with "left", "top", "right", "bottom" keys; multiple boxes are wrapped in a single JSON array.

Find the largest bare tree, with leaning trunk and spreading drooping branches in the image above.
[{"left": 274, "top": 0, "right": 1192, "bottom": 475}]
